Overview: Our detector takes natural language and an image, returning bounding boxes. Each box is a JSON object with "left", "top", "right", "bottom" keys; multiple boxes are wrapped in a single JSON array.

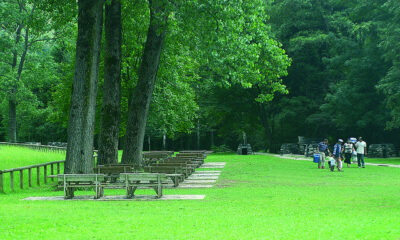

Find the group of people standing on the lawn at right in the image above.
[{"left": 317, "top": 137, "right": 367, "bottom": 172}]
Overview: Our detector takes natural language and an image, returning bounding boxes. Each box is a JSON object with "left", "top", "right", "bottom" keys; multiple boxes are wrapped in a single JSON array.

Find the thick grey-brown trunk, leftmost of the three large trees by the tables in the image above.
[{"left": 64, "top": 0, "right": 104, "bottom": 173}]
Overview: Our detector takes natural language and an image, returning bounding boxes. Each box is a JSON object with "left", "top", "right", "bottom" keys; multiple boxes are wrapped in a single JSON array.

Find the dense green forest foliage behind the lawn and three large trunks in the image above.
[{"left": 0, "top": 0, "right": 400, "bottom": 151}]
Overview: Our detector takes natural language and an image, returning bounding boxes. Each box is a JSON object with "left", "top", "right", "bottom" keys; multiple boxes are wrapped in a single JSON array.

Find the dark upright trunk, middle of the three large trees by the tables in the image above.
[{"left": 97, "top": 0, "right": 121, "bottom": 165}]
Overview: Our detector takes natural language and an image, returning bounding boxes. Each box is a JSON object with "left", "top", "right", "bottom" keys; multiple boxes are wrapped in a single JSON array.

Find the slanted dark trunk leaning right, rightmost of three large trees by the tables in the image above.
[{"left": 122, "top": 0, "right": 167, "bottom": 166}]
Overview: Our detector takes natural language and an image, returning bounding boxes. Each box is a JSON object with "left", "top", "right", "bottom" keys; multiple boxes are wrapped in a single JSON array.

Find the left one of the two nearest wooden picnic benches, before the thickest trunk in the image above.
[{"left": 57, "top": 174, "right": 105, "bottom": 199}]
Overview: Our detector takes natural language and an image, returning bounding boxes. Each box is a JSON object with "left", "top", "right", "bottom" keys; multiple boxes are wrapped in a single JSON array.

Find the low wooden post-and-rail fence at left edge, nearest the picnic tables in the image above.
[{"left": 0, "top": 161, "right": 65, "bottom": 193}]
